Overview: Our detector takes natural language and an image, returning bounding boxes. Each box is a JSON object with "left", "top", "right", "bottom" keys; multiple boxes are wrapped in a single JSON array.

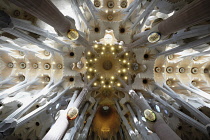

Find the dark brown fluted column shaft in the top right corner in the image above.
[{"left": 158, "top": 0, "right": 210, "bottom": 36}]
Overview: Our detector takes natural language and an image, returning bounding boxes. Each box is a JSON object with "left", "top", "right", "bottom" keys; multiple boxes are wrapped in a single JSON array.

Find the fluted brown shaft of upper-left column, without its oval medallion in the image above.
[{"left": 10, "top": 0, "right": 73, "bottom": 33}]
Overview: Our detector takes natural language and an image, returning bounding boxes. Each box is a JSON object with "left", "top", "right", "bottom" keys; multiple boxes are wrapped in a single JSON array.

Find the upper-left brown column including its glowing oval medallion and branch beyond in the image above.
[{"left": 7, "top": 0, "right": 95, "bottom": 51}]
